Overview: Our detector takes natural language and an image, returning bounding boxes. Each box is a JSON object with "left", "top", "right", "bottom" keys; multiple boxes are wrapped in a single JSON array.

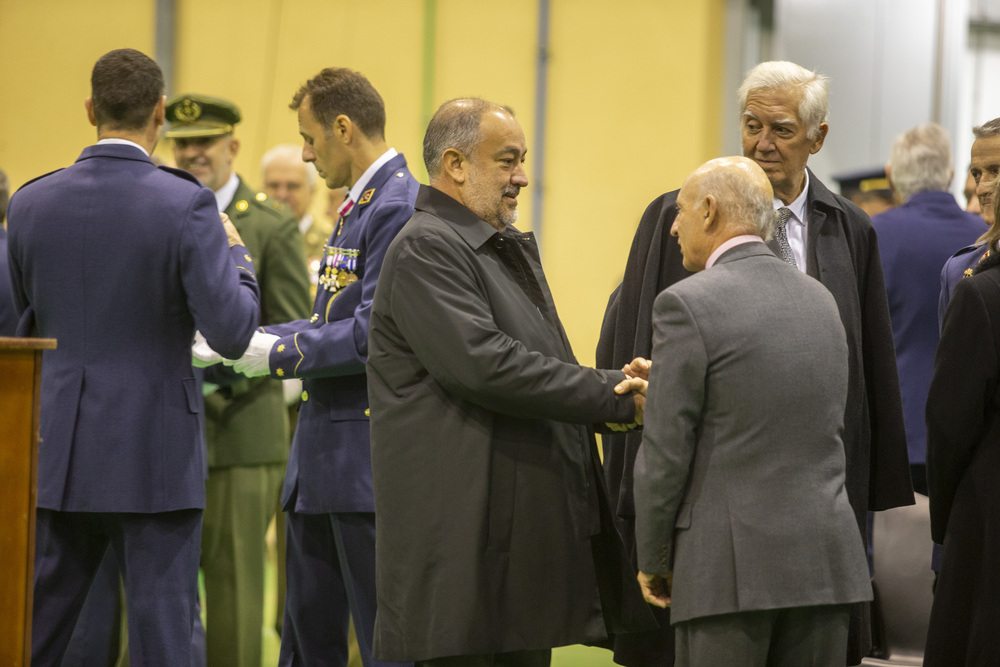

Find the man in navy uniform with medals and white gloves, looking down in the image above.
[{"left": 225, "top": 68, "right": 417, "bottom": 667}]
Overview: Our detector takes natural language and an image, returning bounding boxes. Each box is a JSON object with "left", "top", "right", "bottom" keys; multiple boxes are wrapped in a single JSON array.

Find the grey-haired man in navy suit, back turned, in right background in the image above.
[{"left": 872, "top": 123, "right": 986, "bottom": 495}]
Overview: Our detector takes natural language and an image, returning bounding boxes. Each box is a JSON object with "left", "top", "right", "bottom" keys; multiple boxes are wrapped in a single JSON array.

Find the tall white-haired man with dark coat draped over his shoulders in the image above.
[{"left": 597, "top": 62, "right": 913, "bottom": 665}]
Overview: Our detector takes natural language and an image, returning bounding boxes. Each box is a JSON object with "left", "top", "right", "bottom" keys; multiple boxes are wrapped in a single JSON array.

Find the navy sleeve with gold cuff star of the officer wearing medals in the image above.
[{"left": 265, "top": 200, "right": 413, "bottom": 378}]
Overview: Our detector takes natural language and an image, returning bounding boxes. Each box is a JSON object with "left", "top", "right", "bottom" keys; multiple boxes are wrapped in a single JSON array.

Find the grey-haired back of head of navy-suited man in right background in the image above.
[{"left": 889, "top": 123, "right": 952, "bottom": 201}]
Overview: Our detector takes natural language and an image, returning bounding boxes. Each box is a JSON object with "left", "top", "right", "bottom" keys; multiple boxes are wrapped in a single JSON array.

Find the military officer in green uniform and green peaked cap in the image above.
[{"left": 164, "top": 95, "right": 310, "bottom": 667}]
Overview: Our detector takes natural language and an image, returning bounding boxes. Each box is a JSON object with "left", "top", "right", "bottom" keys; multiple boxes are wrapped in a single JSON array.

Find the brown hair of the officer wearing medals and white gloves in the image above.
[{"left": 288, "top": 67, "right": 385, "bottom": 139}]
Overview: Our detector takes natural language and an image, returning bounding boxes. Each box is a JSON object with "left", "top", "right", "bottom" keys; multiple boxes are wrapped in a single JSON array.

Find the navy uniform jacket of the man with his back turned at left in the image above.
[{"left": 9, "top": 145, "right": 260, "bottom": 512}]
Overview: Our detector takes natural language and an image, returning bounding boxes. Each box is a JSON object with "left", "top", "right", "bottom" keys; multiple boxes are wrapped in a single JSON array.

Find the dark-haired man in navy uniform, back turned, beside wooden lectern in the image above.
[{"left": 9, "top": 49, "right": 260, "bottom": 666}]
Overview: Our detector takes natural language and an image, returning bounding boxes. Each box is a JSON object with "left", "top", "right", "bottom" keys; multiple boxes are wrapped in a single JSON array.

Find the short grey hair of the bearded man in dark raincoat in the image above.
[{"left": 424, "top": 97, "right": 514, "bottom": 178}]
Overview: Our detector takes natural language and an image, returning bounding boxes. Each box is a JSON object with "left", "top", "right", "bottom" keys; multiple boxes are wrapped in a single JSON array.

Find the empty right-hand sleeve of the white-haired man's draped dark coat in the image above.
[{"left": 861, "top": 225, "right": 913, "bottom": 510}]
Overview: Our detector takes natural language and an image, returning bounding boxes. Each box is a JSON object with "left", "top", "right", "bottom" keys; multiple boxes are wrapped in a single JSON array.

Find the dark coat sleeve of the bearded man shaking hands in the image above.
[{"left": 389, "top": 236, "right": 635, "bottom": 424}]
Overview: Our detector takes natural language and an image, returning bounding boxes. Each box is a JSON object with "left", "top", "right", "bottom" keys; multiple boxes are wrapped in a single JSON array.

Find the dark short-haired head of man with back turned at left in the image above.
[{"left": 90, "top": 49, "right": 165, "bottom": 131}]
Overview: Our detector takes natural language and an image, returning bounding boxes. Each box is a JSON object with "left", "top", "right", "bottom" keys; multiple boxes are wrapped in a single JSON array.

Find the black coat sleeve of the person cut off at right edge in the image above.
[{"left": 926, "top": 280, "right": 998, "bottom": 544}]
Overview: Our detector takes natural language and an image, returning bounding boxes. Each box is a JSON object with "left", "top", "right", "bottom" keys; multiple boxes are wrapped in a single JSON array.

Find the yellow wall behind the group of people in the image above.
[{"left": 0, "top": 0, "right": 724, "bottom": 363}]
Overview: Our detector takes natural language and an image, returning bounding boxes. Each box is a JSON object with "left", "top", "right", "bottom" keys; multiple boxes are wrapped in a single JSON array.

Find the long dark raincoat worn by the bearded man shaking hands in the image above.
[{"left": 368, "top": 186, "right": 652, "bottom": 660}]
